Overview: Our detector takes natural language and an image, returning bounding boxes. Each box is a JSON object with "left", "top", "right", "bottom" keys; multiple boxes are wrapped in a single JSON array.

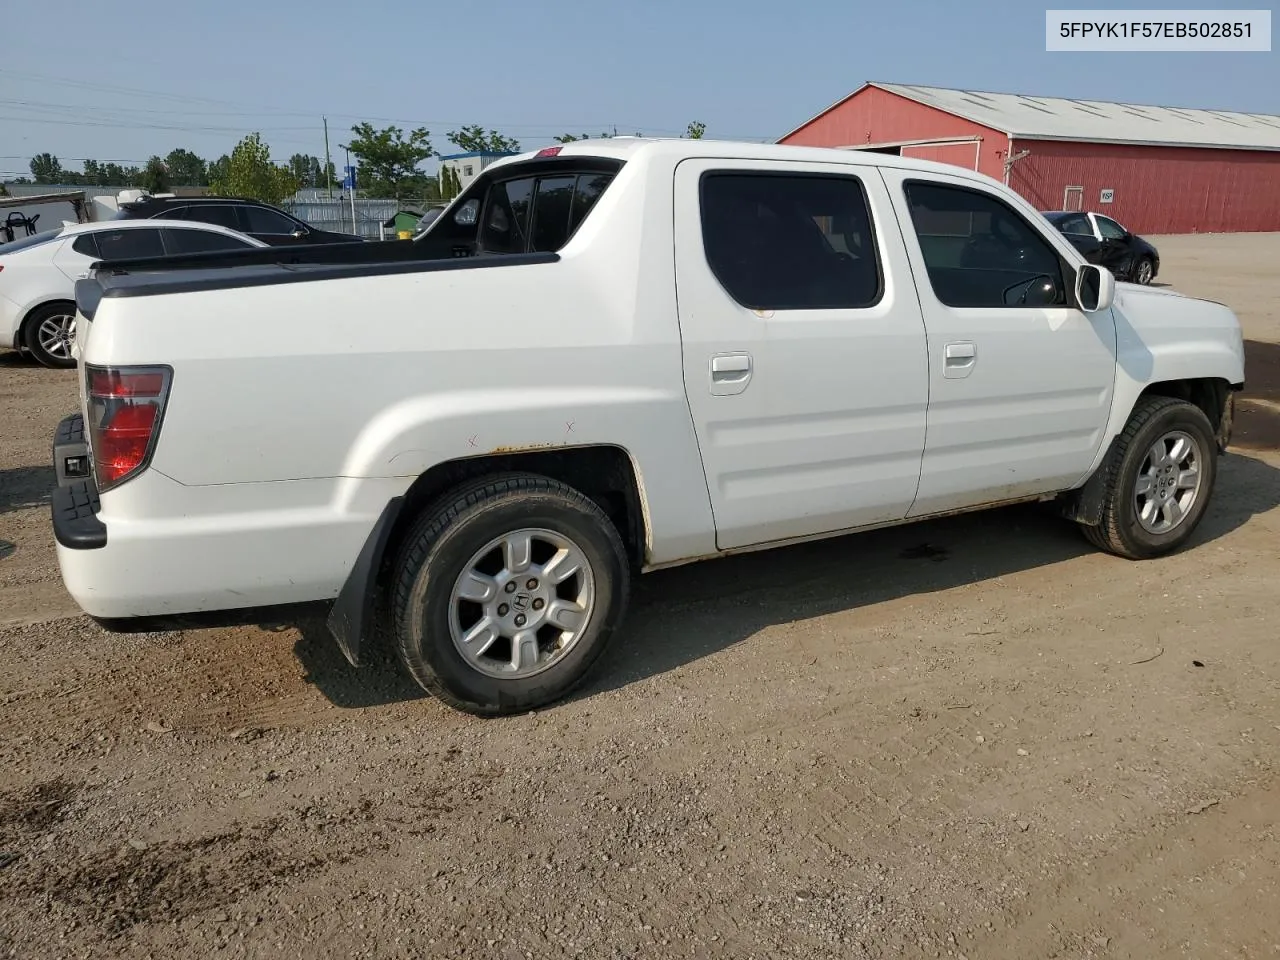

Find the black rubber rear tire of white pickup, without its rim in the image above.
[{"left": 392, "top": 474, "right": 630, "bottom": 717}]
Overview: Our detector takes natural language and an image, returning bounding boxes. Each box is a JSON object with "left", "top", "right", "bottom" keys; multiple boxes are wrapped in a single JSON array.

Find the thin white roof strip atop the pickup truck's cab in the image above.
[{"left": 485, "top": 137, "right": 991, "bottom": 180}]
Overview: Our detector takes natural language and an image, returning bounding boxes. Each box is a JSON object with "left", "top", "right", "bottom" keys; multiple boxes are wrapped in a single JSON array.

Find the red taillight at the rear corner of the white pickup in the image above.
[{"left": 84, "top": 366, "right": 170, "bottom": 490}]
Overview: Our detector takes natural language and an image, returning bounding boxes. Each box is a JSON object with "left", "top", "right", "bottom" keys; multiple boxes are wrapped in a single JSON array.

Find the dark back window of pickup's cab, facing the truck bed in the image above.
[{"left": 477, "top": 173, "right": 613, "bottom": 253}]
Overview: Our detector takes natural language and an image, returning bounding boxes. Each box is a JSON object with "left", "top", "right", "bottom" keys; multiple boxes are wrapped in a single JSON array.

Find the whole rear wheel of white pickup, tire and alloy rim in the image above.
[{"left": 392, "top": 474, "right": 630, "bottom": 716}]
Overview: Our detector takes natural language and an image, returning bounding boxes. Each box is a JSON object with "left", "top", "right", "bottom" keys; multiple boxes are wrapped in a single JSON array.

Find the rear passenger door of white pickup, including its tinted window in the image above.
[{"left": 675, "top": 159, "right": 928, "bottom": 549}]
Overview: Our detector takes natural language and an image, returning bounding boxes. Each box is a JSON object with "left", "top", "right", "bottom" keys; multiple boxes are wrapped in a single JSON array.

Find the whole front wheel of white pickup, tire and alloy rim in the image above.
[{"left": 1084, "top": 397, "right": 1217, "bottom": 559}]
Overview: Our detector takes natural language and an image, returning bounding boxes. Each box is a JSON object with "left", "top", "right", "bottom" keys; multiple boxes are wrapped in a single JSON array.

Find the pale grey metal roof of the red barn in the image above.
[{"left": 786, "top": 82, "right": 1280, "bottom": 150}]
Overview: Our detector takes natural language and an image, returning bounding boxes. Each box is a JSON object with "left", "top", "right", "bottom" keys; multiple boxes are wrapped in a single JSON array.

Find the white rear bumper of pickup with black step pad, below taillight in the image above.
[{"left": 52, "top": 417, "right": 407, "bottom": 619}]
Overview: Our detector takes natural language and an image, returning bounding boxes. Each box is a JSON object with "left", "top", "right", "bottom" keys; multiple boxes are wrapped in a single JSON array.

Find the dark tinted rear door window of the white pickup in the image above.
[{"left": 701, "top": 172, "right": 882, "bottom": 310}]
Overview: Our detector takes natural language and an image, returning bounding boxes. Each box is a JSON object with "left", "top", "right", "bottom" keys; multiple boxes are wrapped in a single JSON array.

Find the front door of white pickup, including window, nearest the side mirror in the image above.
[{"left": 883, "top": 168, "right": 1116, "bottom": 516}]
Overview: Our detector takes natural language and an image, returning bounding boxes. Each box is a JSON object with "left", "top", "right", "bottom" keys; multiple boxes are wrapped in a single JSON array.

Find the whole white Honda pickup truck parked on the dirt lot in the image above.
[{"left": 52, "top": 140, "right": 1244, "bottom": 714}]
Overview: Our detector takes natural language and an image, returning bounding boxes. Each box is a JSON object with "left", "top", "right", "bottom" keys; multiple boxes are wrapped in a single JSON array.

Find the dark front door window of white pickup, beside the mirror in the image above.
[{"left": 906, "top": 180, "right": 1066, "bottom": 307}]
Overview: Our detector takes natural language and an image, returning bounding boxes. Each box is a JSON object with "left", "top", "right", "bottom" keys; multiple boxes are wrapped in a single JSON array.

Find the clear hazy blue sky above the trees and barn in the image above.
[{"left": 0, "top": 0, "right": 1280, "bottom": 178}]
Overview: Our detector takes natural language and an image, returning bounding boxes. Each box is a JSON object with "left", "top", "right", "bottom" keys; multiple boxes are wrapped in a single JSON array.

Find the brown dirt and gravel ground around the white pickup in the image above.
[{"left": 0, "top": 234, "right": 1280, "bottom": 960}]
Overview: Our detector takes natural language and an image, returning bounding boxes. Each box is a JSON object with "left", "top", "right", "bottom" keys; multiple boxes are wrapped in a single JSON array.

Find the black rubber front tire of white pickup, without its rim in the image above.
[{"left": 1082, "top": 397, "right": 1217, "bottom": 559}]
